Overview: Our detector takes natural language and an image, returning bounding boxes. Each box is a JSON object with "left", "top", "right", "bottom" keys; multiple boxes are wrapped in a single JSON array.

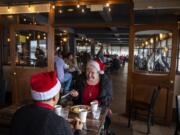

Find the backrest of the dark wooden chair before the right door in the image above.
[{"left": 150, "top": 87, "right": 161, "bottom": 110}]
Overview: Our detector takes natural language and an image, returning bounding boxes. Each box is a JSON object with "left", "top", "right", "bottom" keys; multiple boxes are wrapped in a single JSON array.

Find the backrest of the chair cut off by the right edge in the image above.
[{"left": 176, "top": 95, "right": 180, "bottom": 127}]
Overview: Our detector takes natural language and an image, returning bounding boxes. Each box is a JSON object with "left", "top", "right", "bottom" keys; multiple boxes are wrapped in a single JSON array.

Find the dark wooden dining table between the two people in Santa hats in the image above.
[{"left": 0, "top": 105, "right": 108, "bottom": 135}]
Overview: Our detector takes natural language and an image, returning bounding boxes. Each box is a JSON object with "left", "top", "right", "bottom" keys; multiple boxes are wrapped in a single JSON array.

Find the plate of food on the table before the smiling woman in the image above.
[{"left": 70, "top": 105, "right": 91, "bottom": 113}]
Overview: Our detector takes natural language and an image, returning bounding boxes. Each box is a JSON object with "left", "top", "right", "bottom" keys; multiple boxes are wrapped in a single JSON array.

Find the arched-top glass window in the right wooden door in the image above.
[{"left": 134, "top": 30, "right": 172, "bottom": 73}]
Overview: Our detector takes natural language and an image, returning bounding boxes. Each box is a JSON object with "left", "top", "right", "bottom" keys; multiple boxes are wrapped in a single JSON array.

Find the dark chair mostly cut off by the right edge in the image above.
[{"left": 174, "top": 95, "right": 180, "bottom": 135}]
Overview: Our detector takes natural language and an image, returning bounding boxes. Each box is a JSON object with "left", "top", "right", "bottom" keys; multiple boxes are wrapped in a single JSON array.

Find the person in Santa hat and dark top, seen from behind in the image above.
[{"left": 10, "top": 72, "right": 82, "bottom": 135}]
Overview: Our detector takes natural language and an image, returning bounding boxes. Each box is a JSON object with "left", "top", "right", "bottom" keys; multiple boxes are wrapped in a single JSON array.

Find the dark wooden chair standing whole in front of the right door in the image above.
[{"left": 128, "top": 87, "right": 160, "bottom": 134}]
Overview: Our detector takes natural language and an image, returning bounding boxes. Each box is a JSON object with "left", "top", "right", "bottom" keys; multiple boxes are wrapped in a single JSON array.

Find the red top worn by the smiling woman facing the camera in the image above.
[{"left": 83, "top": 83, "right": 100, "bottom": 105}]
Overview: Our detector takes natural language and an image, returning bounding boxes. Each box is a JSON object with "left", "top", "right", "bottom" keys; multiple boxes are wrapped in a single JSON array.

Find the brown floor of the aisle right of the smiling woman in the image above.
[{"left": 111, "top": 65, "right": 174, "bottom": 135}]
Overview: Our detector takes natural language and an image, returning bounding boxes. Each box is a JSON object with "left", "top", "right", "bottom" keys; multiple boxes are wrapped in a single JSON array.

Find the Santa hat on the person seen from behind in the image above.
[{"left": 31, "top": 71, "right": 61, "bottom": 101}]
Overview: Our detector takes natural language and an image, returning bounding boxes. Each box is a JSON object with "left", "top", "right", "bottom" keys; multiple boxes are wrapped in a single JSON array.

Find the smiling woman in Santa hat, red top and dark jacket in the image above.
[{"left": 71, "top": 60, "right": 112, "bottom": 108}]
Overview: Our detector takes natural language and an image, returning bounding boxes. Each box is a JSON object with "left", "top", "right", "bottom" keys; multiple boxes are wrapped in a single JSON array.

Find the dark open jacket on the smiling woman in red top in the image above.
[{"left": 74, "top": 74, "right": 112, "bottom": 107}]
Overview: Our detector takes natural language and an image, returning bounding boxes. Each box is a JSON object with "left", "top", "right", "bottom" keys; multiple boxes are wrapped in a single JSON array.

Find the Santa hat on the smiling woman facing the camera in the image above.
[{"left": 87, "top": 60, "right": 105, "bottom": 74}]
